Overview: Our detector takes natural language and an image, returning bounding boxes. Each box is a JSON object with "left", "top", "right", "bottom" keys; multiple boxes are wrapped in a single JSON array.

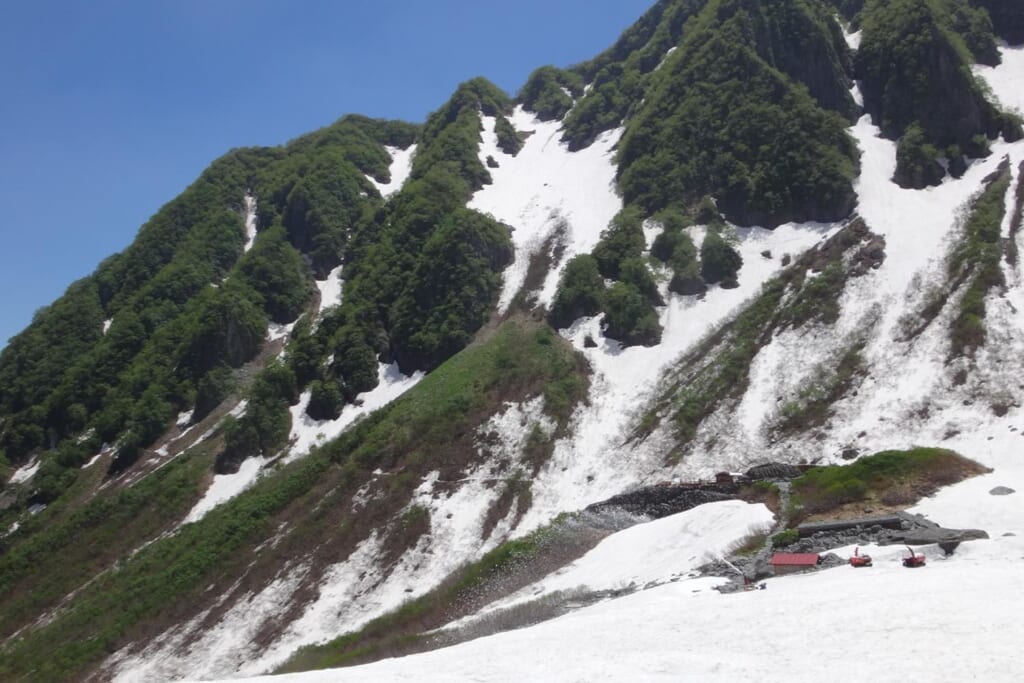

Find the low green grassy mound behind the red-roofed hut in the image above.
[{"left": 791, "top": 447, "right": 986, "bottom": 524}]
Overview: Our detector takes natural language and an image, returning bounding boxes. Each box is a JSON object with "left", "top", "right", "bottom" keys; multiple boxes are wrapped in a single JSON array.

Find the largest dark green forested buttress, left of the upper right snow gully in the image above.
[{"left": 620, "top": 0, "right": 857, "bottom": 226}]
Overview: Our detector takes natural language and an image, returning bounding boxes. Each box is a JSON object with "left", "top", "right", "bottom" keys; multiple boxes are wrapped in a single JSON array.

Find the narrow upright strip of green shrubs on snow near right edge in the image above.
[{"left": 948, "top": 160, "right": 1011, "bottom": 356}]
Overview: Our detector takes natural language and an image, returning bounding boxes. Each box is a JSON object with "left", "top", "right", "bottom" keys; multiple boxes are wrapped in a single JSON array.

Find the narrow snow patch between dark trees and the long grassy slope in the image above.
[{"left": 285, "top": 364, "right": 423, "bottom": 462}]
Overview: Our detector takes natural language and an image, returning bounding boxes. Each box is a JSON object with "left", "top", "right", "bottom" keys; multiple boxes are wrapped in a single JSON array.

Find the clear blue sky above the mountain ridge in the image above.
[{"left": 0, "top": 0, "right": 653, "bottom": 347}]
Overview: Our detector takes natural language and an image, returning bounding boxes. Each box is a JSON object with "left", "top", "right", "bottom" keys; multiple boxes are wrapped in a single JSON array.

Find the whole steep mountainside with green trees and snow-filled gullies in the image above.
[{"left": 0, "top": 0, "right": 1024, "bottom": 681}]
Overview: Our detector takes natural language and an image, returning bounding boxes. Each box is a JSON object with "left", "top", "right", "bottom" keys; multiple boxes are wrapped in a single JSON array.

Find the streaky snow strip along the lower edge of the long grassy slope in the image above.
[{"left": 140, "top": 397, "right": 554, "bottom": 682}]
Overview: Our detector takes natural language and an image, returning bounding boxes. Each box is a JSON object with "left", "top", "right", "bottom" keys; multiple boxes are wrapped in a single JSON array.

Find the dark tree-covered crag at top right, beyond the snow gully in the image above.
[{"left": 857, "top": 0, "right": 1021, "bottom": 186}]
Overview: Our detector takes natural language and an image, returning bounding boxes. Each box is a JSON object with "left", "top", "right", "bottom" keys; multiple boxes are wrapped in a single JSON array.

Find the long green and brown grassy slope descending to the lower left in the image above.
[{"left": 0, "top": 321, "right": 587, "bottom": 681}]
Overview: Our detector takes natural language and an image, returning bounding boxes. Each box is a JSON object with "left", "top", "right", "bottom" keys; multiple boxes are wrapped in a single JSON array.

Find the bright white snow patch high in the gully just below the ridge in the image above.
[{"left": 469, "top": 106, "right": 623, "bottom": 312}]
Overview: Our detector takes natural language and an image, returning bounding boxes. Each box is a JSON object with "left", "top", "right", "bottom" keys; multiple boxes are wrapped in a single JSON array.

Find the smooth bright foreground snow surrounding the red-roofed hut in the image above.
[{"left": 220, "top": 411, "right": 1024, "bottom": 683}]
